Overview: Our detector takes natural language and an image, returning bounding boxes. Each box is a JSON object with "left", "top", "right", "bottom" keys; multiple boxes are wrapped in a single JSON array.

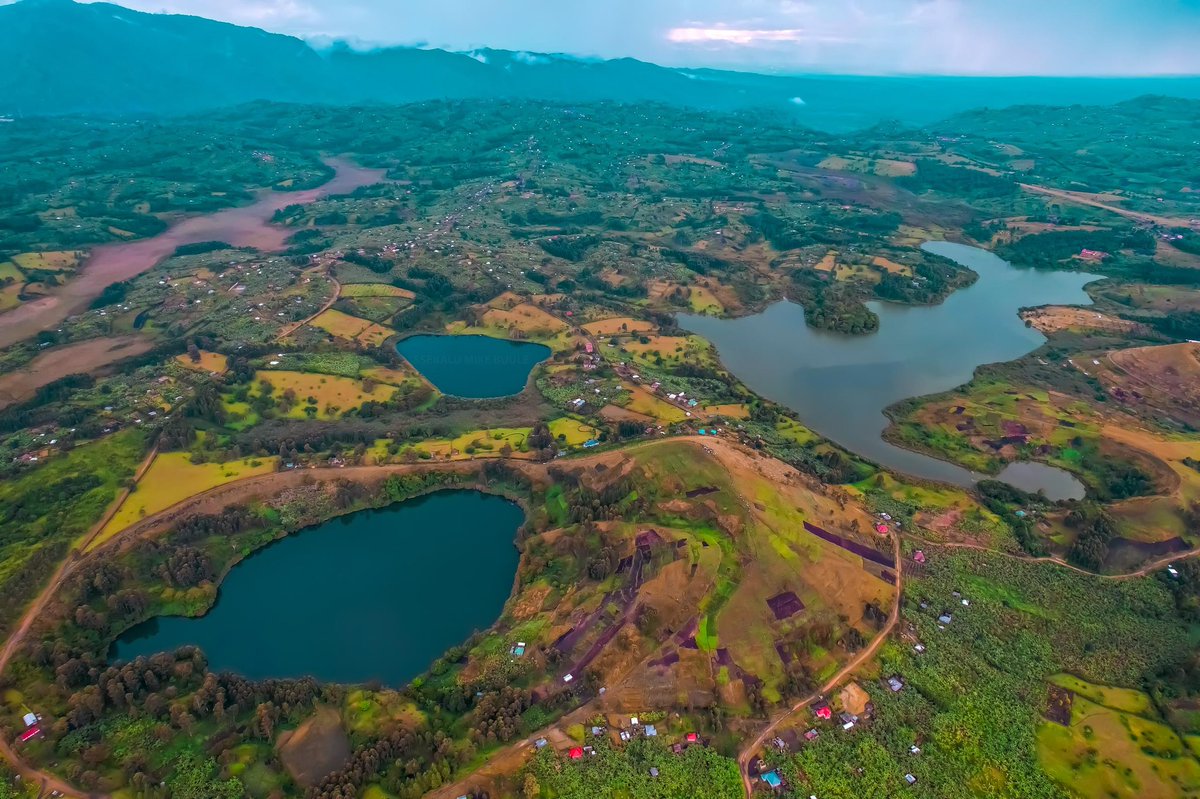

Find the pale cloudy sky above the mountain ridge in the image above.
[{"left": 72, "top": 0, "right": 1200, "bottom": 74}]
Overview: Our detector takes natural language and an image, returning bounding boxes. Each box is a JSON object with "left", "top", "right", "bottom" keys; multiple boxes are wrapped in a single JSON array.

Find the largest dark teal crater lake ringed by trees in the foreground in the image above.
[{"left": 110, "top": 491, "right": 524, "bottom": 686}]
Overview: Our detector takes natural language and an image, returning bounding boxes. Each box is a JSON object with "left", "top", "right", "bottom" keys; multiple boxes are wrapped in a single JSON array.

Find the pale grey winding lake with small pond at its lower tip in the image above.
[{"left": 679, "top": 241, "right": 1100, "bottom": 499}]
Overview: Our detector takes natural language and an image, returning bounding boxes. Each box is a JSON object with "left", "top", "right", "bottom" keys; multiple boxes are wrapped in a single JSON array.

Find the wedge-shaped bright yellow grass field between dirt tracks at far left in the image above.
[{"left": 91, "top": 452, "right": 278, "bottom": 548}]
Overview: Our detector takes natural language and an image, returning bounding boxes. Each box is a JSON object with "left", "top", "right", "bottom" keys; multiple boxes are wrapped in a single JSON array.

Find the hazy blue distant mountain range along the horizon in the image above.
[{"left": 7, "top": 0, "right": 1200, "bottom": 130}]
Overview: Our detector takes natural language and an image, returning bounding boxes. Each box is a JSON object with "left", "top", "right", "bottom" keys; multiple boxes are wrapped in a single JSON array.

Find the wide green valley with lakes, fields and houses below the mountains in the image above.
[{"left": 0, "top": 48, "right": 1200, "bottom": 799}]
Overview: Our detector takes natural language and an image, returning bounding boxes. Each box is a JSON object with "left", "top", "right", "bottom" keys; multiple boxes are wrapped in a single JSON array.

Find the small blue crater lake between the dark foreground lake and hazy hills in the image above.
[{"left": 396, "top": 336, "right": 551, "bottom": 400}]
